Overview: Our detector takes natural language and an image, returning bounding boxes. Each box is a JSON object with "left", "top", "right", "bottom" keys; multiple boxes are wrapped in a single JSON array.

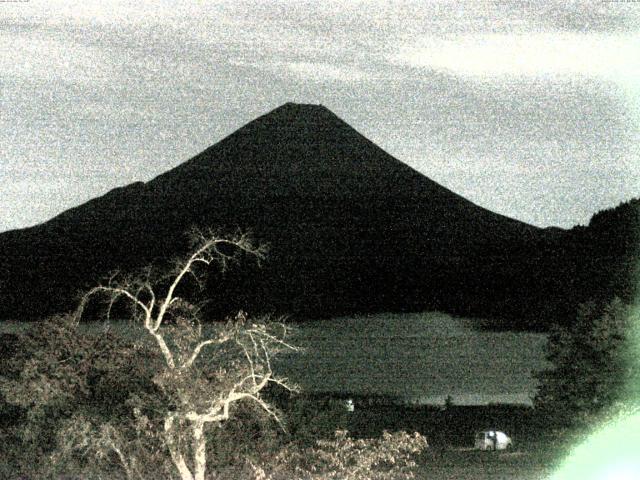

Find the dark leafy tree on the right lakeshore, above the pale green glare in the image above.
[{"left": 534, "top": 299, "right": 635, "bottom": 430}]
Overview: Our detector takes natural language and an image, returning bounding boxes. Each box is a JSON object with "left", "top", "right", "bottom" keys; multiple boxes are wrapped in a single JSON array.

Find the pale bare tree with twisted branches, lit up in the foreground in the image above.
[{"left": 75, "top": 232, "right": 296, "bottom": 480}]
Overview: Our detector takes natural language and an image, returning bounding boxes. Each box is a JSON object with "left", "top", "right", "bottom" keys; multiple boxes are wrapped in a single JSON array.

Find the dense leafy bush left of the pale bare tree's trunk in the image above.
[{"left": 0, "top": 317, "right": 170, "bottom": 475}]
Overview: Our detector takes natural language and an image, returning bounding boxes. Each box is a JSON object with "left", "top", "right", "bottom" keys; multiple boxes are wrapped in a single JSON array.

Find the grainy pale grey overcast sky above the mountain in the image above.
[{"left": 0, "top": 0, "right": 640, "bottom": 231}]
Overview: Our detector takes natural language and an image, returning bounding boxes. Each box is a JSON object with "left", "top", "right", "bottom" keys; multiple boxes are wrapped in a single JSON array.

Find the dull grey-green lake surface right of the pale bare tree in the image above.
[{"left": 274, "top": 313, "right": 547, "bottom": 405}]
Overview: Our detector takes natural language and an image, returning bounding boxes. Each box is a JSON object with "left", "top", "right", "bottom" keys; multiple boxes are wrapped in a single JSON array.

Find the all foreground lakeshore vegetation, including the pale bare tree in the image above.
[{"left": 0, "top": 227, "right": 640, "bottom": 480}]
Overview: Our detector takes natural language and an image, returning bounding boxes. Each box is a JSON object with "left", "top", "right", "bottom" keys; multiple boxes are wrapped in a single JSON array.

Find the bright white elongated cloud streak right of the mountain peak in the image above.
[{"left": 392, "top": 32, "right": 640, "bottom": 80}]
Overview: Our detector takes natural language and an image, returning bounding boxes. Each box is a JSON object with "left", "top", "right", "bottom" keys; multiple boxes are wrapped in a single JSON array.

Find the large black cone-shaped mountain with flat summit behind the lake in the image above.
[{"left": 0, "top": 103, "right": 636, "bottom": 327}]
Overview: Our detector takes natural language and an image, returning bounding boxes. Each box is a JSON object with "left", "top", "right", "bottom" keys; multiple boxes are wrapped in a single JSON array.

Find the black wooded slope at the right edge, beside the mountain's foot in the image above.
[{"left": 478, "top": 199, "right": 640, "bottom": 330}]
